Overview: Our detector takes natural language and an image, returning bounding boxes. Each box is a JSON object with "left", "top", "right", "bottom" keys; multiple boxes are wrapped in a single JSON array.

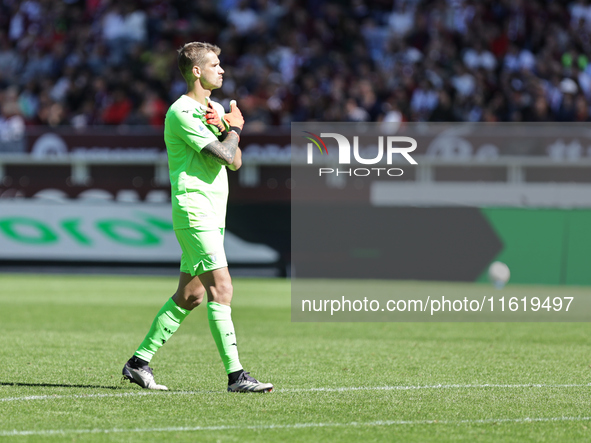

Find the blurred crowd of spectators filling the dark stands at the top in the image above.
[{"left": 0, "top": 0, "right": 591, "bottom": 131}]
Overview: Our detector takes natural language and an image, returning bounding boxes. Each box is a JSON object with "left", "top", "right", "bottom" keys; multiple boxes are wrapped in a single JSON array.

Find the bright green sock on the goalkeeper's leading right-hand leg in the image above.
[{"left": 207, "top": 302, "right": 242, "bottom": 374}]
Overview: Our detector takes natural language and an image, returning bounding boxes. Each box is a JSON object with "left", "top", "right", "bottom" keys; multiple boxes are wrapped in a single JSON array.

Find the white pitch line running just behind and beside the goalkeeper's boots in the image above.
[{"left": 0, "top": 383, "right": 591, "bottom": 402}]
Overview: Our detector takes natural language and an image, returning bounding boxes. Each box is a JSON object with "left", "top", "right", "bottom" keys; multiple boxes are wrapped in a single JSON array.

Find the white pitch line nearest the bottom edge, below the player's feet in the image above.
[{"left": 0, "top": 417, "right": 591, "bottom": 437}]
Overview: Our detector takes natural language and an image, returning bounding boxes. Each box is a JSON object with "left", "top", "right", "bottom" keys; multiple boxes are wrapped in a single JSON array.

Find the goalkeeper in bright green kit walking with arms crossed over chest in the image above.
[{"left": 123, "top": 42, "right": 273, "bottom": 392}]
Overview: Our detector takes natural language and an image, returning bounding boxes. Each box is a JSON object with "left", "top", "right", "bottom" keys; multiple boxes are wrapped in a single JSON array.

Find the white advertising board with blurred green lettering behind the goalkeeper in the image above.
[{"left": 0, "top": 199, "right": 279, "bottom": 264}]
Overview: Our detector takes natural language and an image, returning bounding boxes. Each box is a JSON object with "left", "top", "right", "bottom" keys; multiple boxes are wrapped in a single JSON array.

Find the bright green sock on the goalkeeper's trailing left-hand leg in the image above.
[{"left": 134, "top": 298, "right": 191, "bottom": 362}]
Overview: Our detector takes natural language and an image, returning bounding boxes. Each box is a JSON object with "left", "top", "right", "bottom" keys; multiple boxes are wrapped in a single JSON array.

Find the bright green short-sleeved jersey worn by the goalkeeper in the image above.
[{"left": 164, "top": 95, "right": 234, "bottom": 231}]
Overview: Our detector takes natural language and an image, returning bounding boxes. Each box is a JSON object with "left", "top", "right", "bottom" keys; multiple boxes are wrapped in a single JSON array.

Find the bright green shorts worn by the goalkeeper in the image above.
[{"left": 174, "top": 228, "right": 228, "bottom": 276}]
